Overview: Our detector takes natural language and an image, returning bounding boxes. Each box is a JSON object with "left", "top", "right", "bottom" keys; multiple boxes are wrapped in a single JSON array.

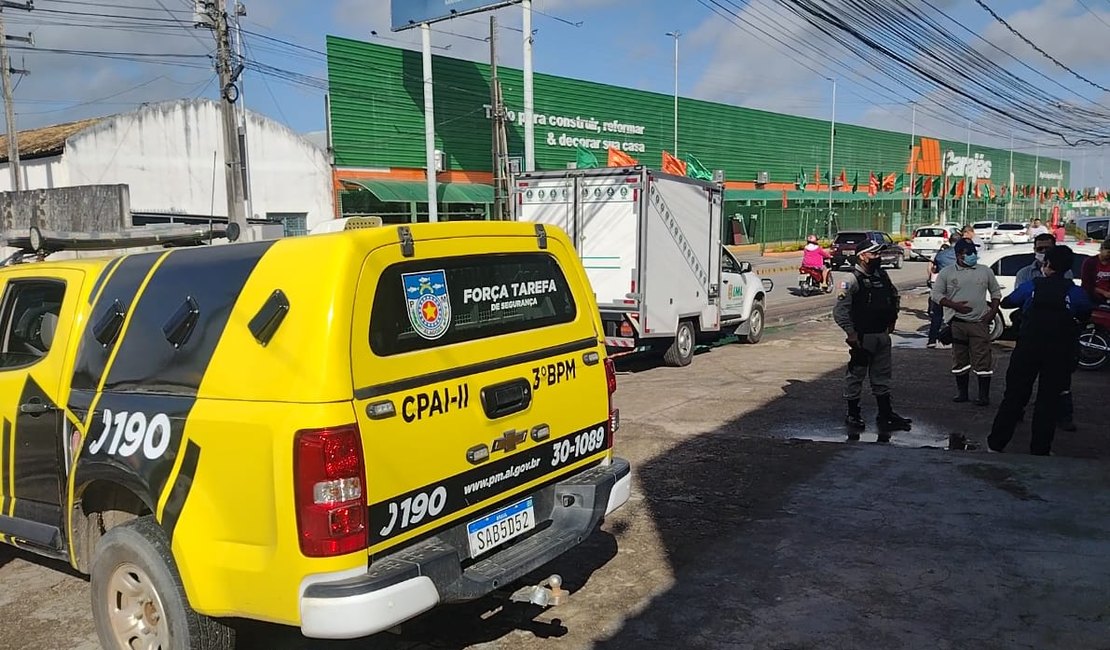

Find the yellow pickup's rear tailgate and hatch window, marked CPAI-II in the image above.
[{"left": 351, "top": 236, "right": 612, "bottom": 557}]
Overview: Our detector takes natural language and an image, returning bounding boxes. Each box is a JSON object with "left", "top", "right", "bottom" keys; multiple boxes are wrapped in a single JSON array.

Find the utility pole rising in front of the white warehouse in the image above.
[{"left": 200, "top": 0, "right": 251, "bottom": 236}]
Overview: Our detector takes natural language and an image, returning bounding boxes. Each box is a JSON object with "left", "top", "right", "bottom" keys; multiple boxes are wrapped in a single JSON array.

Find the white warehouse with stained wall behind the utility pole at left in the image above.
[{"left": 0, "top": 100, "right": 335, "bottom": 235}]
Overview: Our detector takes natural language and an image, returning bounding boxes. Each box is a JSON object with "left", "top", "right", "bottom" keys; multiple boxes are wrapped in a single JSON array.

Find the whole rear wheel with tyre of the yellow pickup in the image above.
[{"left": 90, "top": 516, "right": 235, "bottom": 650}]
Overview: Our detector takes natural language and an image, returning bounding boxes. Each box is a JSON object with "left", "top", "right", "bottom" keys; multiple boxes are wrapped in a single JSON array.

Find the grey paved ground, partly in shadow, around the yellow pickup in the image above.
[{"left": 0, "top": 288, "right": 1110, "bottom": 650}]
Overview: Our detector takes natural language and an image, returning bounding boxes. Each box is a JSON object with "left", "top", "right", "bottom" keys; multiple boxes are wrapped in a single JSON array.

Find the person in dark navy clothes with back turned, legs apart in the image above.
[{"left": 987, "top": 245, "right": 1091, "bottom": 456}]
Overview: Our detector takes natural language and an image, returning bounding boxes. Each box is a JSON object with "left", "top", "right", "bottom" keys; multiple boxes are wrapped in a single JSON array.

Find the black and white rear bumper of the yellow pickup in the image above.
[{"left": 301, "top": 458, "right": 632, "bottom": 639}]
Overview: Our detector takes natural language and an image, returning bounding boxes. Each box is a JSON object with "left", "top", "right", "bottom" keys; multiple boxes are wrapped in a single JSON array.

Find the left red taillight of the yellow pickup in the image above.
[{"left": 293, "top": 425, "right": 369, "bottom": 558}]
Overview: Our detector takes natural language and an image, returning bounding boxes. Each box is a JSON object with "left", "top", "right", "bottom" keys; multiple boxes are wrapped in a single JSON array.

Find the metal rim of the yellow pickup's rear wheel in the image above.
[{"left": 107, "top": 562, "right": 170, "bottom": 650}]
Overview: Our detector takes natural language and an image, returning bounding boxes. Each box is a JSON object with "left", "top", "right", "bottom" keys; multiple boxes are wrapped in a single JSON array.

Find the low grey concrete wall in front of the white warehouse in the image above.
[{"left": 0, "top": 185, "right": 131, "bottom": 231}]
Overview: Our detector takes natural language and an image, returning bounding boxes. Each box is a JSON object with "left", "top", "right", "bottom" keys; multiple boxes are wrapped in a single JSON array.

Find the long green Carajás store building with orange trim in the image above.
[{"left": 327, "top": 37, "right": 1071, "bottom": 243}]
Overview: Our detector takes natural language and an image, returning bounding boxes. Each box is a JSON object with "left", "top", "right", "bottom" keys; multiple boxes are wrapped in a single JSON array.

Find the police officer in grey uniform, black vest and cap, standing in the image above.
[{"left": 833, "top": 239, "right": 911, "bottom": 443}]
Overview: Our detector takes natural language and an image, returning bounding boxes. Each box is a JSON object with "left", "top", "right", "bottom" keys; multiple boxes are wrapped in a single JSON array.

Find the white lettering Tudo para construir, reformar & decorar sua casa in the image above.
[{"left": 483, "top": 104, "right": 647, "bottom": 153}]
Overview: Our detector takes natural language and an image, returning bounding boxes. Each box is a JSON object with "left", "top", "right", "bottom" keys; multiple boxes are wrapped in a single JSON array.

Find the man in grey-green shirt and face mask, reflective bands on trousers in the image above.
[{"left": 931, "top": 238, "right": 1002, "bottom": 406}]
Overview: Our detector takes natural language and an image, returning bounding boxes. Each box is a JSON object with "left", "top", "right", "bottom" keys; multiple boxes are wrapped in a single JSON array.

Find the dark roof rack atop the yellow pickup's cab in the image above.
[{"left": 0, "top": 223, "right": 240, "bottom": 266}]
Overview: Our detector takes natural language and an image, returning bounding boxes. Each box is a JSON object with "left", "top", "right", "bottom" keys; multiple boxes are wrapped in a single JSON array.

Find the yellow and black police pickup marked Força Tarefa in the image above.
[{"left": 0, "top": 223, "right": 630, "bottom": 650}]
